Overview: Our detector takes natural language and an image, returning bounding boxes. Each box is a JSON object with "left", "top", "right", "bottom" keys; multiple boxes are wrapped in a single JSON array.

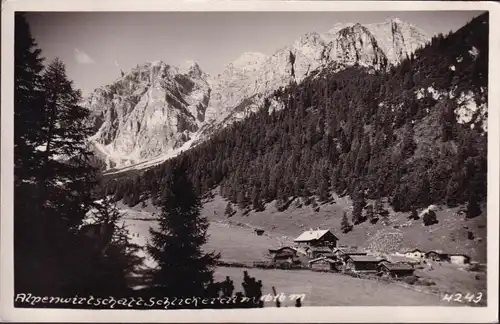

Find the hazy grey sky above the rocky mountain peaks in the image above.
[{"left": 27, "top": 11, "right": 482, "bottom": 95}]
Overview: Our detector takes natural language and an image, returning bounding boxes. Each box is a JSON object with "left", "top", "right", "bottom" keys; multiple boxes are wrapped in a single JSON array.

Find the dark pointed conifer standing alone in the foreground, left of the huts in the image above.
[{"left": 147, "top": 164, "right": 219, "bottom": 297}]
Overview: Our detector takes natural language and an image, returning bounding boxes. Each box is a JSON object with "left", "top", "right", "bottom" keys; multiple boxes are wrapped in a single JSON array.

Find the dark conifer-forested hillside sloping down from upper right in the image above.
[{"left": 104, "top": 13, "right": 489, "bottom": 217}]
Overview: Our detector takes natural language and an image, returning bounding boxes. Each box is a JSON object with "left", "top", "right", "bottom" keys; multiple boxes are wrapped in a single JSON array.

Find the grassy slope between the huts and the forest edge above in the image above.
[{"left": 203, "top": 195, "right": 486, "bottom": 262}]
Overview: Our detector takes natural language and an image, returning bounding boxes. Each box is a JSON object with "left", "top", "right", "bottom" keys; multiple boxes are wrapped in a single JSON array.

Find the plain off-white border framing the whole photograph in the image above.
[{"left": 0, "top": 0, "right": 500, "bottom": 323}]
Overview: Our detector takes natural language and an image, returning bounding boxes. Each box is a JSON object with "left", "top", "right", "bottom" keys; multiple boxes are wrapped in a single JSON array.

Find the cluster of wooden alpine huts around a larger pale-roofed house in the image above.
[{"left": 269, "top": 229, "right": 470, "bottom": 277}]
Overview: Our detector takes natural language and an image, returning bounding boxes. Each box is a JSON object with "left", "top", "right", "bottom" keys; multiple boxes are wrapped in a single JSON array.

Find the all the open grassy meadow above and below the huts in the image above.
[{"left": 119, "top": 196, "right": 486, "bottom": 306}]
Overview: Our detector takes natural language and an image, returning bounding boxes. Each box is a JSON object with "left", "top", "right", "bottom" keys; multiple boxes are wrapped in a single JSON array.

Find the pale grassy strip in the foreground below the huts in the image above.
[{"left": 215, "top": 267, "right": 458, "bottom": 307}]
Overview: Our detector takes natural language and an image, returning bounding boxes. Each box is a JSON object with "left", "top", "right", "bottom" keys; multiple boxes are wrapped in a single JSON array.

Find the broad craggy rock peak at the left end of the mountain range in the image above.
[{"left": 87, "top": 62, "right": 210, "bottom": 167}]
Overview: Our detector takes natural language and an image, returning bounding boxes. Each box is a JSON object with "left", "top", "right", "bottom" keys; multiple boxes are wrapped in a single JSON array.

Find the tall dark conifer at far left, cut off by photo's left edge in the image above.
[{"left": 14, "top": 13, "right": 47, "bottom": 293}]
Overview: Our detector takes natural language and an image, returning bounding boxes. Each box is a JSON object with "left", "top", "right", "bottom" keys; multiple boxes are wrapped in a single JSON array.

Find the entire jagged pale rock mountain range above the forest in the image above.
[{"left": 86, "top": 20, "right": 429, "bottom": 168}]
